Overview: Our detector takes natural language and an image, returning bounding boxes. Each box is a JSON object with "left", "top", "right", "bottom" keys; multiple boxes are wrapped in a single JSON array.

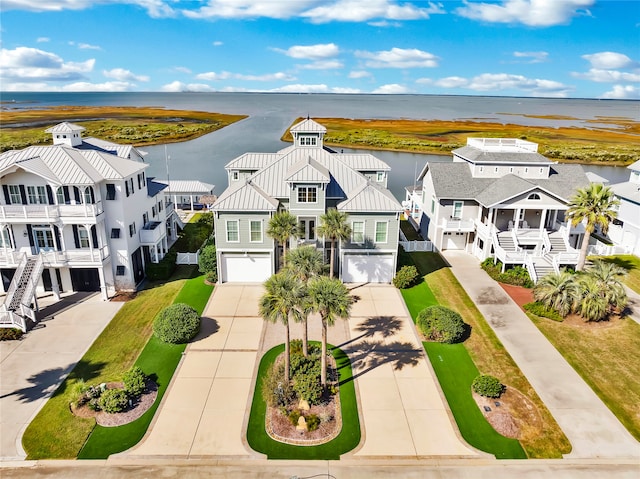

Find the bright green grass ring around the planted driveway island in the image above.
[{"left": 247, "top": 344, "right": 360, "bottom": 460}]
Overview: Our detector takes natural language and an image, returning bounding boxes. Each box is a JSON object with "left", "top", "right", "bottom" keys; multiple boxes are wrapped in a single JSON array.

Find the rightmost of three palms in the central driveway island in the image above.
[{"left": 307, "top": 276, "right": 353, "bottom": 387}]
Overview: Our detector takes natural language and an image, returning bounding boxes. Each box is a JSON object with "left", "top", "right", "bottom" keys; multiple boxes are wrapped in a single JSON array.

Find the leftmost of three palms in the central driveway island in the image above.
[{"left": 260, "top": 272, "right": 303, "bottom": 383}]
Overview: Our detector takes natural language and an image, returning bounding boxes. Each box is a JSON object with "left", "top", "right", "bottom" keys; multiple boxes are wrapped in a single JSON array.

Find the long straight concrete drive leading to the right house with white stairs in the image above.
[{"left": 444, "top": 251, "right": 640, "bottom": 459}]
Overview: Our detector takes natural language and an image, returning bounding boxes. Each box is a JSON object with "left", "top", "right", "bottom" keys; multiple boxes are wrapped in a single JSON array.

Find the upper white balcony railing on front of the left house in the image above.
[{"left": 0, "top": 202, "right": 103, "bottom": 223}]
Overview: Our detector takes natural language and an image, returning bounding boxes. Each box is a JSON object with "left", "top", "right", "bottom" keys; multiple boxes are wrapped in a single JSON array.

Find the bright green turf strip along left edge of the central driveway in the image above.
[{"left": 78, "top": 275, "right": 213, "bottom": 459}]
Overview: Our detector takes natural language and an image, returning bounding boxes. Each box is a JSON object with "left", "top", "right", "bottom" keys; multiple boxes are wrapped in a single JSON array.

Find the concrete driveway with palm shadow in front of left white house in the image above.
[{"left": 0, "top": 295, "right": 124, "bottom": 461}]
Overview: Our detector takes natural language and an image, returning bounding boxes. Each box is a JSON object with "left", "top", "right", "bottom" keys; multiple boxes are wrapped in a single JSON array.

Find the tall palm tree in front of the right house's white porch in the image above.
[{"left": 567, "top": 183, "right": 620, "bottom": 271}]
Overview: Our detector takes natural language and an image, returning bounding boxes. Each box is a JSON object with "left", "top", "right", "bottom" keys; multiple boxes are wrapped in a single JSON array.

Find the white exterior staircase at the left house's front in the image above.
[{"left": 0, "top": 255, "right": 44, "bottom": 331}]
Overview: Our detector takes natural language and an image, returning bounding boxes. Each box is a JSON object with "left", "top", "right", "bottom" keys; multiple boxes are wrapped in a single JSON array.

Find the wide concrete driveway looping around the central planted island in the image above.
[{"left": 130, "top": 284, "right": 478, "bottom": 459}]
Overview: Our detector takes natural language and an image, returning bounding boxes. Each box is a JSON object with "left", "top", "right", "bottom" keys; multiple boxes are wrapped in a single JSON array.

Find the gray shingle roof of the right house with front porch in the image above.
[{"left": 424, "top": 162, "right": 589, "bottom": 207}]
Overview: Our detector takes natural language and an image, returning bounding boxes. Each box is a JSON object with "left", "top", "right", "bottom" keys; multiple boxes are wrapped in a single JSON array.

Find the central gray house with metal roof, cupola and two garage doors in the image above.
[{"left": 212, "top": 119, "right": 402, "bottom": 283}]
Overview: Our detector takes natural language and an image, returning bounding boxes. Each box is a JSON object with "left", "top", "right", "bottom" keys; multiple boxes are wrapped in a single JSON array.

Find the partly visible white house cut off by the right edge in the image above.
[{"left": 608, "top": 160, "right": 640, "bottom": 256}]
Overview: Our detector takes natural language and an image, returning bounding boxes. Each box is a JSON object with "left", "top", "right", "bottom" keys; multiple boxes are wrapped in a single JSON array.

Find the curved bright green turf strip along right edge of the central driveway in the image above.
[{"left": 422, "top": 342, "right": 527, "bottom": 459}]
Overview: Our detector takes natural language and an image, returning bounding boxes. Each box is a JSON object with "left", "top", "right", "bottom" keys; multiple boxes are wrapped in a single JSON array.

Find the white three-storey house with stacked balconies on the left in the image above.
[{"left": 0, "top": 122, "right": 176, "bottom": 327}]
